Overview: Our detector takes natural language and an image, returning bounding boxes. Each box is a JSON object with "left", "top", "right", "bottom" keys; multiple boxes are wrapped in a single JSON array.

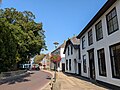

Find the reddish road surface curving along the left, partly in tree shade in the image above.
[{"left": 0, "top": 71, "right": 52, "bottom": 90}]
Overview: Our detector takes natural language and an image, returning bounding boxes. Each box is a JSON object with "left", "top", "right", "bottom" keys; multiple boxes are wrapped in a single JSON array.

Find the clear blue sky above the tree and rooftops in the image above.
[{"left": 0, "top": 0, "right": 107, "bottom": 53}]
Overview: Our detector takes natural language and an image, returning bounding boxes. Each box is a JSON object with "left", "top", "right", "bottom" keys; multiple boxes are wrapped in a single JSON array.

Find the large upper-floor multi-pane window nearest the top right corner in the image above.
[{"left": 106, "top": 8, "right": 119, "bottom": 35}]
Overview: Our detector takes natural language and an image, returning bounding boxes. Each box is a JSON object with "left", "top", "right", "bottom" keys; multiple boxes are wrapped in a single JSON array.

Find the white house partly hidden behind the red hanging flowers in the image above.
[{"left": 51, "top": 42, "right": 66, "bottom": 72}]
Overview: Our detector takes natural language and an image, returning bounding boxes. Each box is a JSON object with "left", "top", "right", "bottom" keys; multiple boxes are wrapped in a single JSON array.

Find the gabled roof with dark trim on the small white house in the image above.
[{"left": 63, "top": 36, "right": 80, "bottom": 54}]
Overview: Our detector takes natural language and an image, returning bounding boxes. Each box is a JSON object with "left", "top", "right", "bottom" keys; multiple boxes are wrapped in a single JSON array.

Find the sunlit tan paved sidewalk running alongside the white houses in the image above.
[{"left": 42, "top": 72, "right": 107, "bottom": 90}]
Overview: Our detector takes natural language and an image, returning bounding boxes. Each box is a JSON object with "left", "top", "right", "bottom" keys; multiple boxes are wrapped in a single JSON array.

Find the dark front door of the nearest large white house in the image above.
[{"left": 88, "top": 49, "right": 95, "bottom": 79}]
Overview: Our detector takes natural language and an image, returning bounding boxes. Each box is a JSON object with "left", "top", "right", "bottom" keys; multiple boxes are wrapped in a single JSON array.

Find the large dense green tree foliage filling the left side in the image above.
[{"left": 0, "top": 8, "right": 46, "bottom": 72}]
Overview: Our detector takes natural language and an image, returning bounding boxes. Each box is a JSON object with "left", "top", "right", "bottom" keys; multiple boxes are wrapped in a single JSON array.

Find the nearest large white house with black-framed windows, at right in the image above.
[{"left": 77, "top": 0, "right": 120, "bottom": 86}]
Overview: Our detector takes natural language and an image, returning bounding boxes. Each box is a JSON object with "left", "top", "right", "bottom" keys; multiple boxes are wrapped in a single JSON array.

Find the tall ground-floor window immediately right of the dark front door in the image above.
[{"left": 97, "top": 49, "right": 106, "bottom": 76}]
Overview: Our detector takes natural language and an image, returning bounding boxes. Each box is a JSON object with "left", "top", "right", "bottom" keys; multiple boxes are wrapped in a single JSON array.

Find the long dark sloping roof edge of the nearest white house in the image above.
[{"left": 77, "top": 0, "right": 117, "bottom": 38}]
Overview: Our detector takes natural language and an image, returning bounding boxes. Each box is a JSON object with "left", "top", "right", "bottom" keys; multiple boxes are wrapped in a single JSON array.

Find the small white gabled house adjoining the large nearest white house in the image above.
[{"left": 64, "top": 36, "right": 81, "bottom": 75}]
